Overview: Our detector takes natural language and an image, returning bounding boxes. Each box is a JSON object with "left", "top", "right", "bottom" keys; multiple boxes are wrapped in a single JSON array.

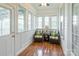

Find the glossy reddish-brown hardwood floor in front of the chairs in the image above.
[{"left": 19, "top": 42, "right": 64, "bottom": 56}]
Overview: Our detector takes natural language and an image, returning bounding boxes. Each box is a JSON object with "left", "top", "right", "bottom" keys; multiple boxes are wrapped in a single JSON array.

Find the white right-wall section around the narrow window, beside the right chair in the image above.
[{"left": 59, "top": 5, "right": 67, "bottom": 55}]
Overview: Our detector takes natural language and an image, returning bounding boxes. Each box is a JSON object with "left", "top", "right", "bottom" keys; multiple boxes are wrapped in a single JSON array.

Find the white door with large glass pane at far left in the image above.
[{"left": 0, "top": 4, "right": 15, "bottom": 56}]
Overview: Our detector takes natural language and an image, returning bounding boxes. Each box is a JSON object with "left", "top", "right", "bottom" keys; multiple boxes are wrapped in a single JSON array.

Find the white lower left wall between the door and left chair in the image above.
[{"left": 15, "top": 31, "right": 34, "bottom": 55}]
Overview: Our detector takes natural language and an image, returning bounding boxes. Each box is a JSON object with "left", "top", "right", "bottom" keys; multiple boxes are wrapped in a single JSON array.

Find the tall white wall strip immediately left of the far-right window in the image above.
[{"left": 61, "top": 4, "right": 72, "bottom": 56}]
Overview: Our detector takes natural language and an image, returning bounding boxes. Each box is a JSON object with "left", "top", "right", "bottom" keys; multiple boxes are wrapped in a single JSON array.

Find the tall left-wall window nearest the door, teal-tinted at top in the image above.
[{"left": 18, "top": 8, "right": 25, "bottom": 32}]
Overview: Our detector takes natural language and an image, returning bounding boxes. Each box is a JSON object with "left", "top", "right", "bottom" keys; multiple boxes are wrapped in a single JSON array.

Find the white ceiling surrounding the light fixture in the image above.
[{"left": 31, "top": 3, "right": 61, "bottom": 11}]
